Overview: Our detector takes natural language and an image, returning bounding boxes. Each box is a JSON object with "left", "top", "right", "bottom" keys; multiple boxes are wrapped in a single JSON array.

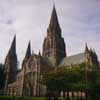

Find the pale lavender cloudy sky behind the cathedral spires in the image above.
[{"left": 0, "top": 0, "right": 100, "bottom": 65}]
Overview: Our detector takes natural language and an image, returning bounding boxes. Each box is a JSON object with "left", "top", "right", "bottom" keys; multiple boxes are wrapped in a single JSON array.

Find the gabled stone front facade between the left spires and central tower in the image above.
[{"left": 23, "top": 54, "right": 41, "bottom": 96}]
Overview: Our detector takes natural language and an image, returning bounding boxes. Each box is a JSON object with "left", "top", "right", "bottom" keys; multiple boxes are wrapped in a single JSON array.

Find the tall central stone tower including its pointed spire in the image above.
[{"left": 42, "top": 5, "right": 66, "bottom": 66}]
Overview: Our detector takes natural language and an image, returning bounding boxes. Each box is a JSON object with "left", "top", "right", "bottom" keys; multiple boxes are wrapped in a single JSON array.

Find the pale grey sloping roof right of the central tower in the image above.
[{"left": 59, "top": 53, "right": 85, "bottom": 66}]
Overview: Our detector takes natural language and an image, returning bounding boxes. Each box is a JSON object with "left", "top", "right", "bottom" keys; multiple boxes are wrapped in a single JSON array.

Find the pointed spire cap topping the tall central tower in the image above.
[{"left": 47, "top": 5, "right": 61, "bottom": 36}]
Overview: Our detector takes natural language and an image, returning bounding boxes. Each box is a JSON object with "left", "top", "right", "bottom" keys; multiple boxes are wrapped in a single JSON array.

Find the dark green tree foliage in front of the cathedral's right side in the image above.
[{"left": 43, "top": 63, "right": 100, "bottom": 100}]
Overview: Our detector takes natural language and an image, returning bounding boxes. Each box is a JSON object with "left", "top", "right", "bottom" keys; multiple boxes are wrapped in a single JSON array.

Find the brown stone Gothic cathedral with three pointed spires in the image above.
[{"left": 4, "top": 6, "right": 99, "bottom": 96}]
